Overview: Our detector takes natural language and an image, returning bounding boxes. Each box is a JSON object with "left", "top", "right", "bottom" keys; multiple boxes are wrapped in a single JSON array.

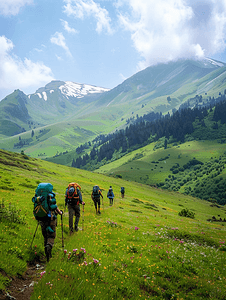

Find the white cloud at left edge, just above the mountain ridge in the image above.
[{"left": 0, "top": 36, "right": 53, "bottom": 95}]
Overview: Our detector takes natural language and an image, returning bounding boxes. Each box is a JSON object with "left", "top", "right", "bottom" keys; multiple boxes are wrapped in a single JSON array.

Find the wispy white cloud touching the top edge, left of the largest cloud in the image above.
[{"left": 64, "top": 0, "right": 113, "bottom": 34}]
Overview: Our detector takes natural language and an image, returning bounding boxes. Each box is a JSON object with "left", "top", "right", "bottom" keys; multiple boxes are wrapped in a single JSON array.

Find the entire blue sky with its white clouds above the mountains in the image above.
[{"left": 0, "top": 0, "right": 226, "bottom": 100}]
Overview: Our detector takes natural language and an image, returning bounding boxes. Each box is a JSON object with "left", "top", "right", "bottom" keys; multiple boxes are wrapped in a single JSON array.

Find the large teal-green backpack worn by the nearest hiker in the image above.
[{"left": 32, "top": 183, "right": 57, "bottom": 220}]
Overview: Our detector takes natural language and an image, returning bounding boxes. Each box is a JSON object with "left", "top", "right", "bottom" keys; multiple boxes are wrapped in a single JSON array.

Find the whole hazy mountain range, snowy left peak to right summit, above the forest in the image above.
[{"left": 0, "top": 59, "right": 226, "bottom": 158}]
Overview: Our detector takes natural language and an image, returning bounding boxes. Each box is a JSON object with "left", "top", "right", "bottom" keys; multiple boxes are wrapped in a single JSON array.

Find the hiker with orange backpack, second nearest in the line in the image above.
[{"left": 65, "top": 182, "right": 85, "bottom": 234}]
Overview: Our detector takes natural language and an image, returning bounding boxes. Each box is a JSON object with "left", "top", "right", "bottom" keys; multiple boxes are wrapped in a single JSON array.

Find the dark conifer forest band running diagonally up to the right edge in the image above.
[{"left": 72, "top": 94, "right": 226, "bottom": 170}]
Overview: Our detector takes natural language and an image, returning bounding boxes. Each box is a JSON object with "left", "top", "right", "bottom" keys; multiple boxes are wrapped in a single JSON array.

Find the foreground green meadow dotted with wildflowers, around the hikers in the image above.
[{"left": 0, "top": 150, "right": 226, "bottom": 300}]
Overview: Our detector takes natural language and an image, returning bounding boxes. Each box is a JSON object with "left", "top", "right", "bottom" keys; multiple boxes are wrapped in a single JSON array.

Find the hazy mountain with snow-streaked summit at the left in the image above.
[{"left": 0, "top": 81, "right": 108, "bottom": 132}]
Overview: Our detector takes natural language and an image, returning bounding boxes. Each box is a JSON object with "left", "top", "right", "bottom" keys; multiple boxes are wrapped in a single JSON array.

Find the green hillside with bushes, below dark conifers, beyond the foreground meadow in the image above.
[{"left": 95, "top": 140, "right": 226, "bottom": 204}]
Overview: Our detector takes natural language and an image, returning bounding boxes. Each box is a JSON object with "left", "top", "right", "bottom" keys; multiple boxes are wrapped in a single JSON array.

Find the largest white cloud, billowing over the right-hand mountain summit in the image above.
[{"left": 117, "top": 0, "right": 226, "bottom": 68}]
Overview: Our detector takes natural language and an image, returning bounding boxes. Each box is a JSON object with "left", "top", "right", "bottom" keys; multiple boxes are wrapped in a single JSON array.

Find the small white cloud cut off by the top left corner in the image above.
[{"left": 0, "top": 0, "right": 33, "bottom": 16}]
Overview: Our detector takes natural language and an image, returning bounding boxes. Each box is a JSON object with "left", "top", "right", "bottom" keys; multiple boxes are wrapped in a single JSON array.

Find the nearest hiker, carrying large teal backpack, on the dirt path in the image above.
[{"left": 32, "top": 183, "right": 63, "bottom": 261}]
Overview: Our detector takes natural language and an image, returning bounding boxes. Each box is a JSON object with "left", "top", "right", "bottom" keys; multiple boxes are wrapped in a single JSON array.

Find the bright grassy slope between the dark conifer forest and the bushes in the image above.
[{"left": 95, "top": 141, "right": 226, "bottom": 184}]
